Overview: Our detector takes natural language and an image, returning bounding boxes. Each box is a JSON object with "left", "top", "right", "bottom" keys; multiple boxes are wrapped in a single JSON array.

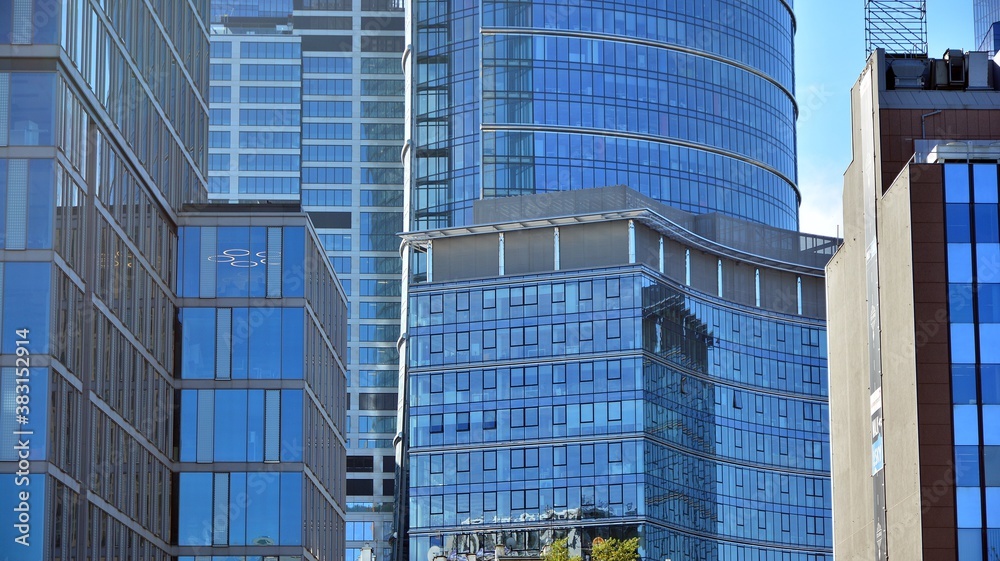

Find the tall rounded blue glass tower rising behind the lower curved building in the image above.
[{"left": 404, "top": 0, "right": 799, "bottom": 230}]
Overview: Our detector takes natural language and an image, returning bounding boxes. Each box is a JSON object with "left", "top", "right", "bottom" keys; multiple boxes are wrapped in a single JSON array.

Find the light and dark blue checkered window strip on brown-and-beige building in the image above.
[{"left": 944, "top": 164, "right": 1000, "bottom": 561}]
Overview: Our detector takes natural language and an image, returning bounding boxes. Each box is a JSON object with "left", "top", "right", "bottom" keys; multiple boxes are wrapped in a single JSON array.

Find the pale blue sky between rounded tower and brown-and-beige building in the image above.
[{"left": 795, "top": 0, "right": 975, "bottom": 236}]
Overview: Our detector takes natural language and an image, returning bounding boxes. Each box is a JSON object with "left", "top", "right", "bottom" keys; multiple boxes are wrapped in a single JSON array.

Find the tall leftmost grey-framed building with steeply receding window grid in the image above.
[{"left": 0, "top": 2, "right": 208, "bottom": 561}]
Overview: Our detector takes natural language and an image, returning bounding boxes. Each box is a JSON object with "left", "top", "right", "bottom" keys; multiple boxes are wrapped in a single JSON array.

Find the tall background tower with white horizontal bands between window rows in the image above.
[{"left": 208, "top": 0, "right": 404, "bottom": 561}]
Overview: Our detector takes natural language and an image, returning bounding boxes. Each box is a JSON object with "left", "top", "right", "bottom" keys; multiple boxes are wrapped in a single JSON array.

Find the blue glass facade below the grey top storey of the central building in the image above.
[{"left": 408, "top": 268, "right": 831, "bottom": 560}]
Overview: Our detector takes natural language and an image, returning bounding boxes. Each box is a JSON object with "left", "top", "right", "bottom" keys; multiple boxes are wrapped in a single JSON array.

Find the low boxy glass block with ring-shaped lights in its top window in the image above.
[{"left": 177, "top": 205, "right": 347, "bottom": 561}]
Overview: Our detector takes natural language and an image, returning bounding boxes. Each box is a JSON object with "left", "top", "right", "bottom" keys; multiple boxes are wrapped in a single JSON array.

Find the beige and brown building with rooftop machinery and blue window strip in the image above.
[{"left": 827, "top": 50, "right": 1000, "bottom": 561}]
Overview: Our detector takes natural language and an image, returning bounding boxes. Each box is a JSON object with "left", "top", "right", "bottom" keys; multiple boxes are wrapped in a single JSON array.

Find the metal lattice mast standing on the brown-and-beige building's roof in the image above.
[{"left": 865, "top": 0, "right": 927, "bottom": 57}]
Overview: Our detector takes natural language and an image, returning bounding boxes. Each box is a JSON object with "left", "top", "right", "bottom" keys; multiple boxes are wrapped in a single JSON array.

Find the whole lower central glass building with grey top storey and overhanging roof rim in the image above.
[{"left": 405, "top": 187, "right": 835, "bottom": 561}]
